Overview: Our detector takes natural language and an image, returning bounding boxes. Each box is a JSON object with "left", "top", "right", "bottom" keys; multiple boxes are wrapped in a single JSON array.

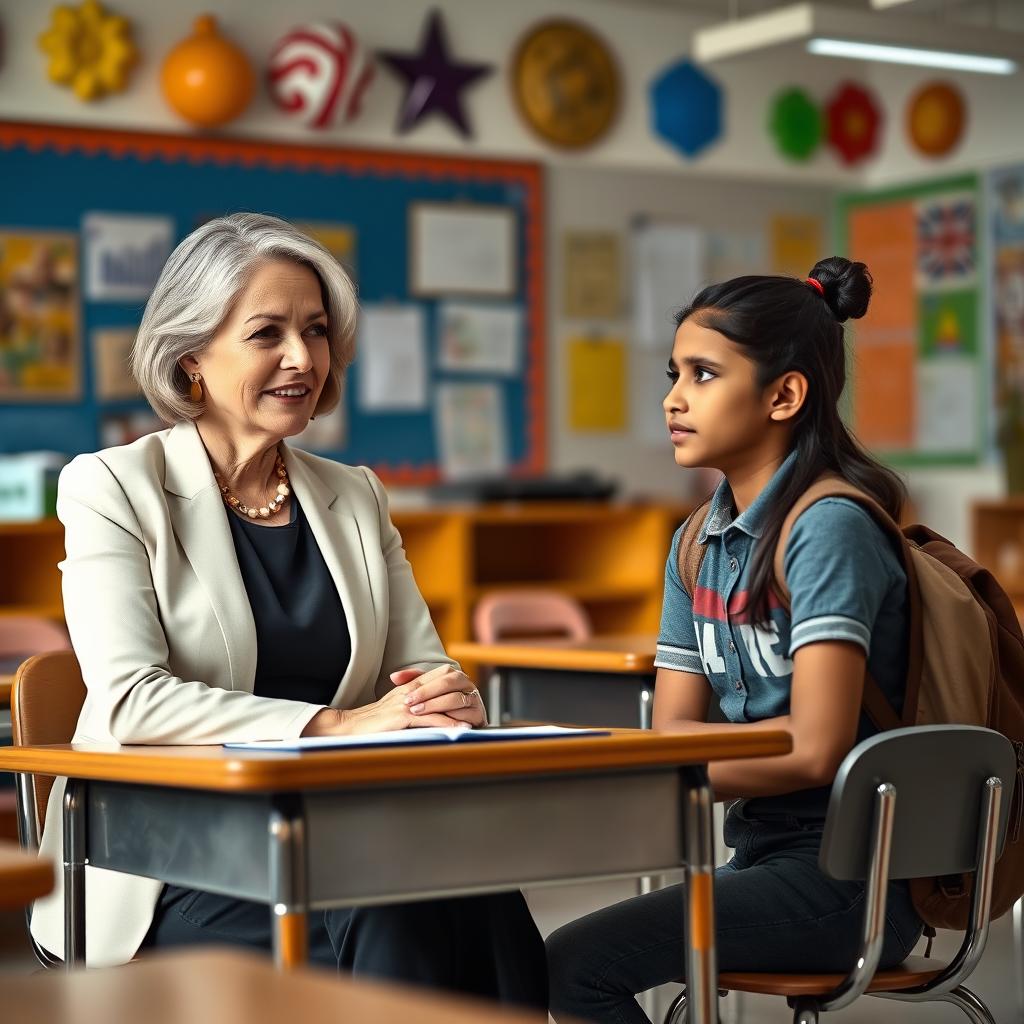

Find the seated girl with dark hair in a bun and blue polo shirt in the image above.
[{"left": 548, "top": 257, "right": 923, "bottom": 1024}]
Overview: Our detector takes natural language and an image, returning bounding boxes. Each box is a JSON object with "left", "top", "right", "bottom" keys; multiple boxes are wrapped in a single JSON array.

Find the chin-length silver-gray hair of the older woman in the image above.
[{"left": 131, "top": 213, "right": 356, "bottom": 423}]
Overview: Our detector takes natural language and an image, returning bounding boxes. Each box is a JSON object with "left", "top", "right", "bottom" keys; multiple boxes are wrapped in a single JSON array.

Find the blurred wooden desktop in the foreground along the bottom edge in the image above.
[{"left": 3, "top": 949, "right": 565, "bottom": 1024}]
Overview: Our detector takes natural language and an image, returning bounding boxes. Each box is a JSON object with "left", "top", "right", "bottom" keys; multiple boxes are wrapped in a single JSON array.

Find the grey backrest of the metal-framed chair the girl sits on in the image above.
[{"left": 819, "top": 725, "right": 1017, "bottom": 881}]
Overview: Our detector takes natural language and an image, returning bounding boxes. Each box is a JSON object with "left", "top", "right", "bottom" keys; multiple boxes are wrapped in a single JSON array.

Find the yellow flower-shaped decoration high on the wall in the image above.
[{"left": 39, "top": 0, "right": 138, "bottom": 100}]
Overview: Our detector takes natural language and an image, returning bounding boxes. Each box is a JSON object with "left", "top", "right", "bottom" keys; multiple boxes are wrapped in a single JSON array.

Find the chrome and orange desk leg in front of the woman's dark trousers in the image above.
[{"left": 269, "top": 802, "right": 309, "bottom": 970}]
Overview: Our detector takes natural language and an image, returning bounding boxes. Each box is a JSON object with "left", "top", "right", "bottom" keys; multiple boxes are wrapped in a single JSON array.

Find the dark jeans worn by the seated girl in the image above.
[{"left": 548, "top": 813, "right": 924, "bottom": 1024}]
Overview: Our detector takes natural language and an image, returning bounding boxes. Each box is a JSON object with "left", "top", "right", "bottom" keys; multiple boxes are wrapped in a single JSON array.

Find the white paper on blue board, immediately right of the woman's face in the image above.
[{"left": 355, "top": 305, "right": 427, "bottom": 411}]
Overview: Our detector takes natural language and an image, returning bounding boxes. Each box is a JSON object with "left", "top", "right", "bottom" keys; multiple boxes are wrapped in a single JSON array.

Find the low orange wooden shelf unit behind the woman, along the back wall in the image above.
[{"left": 0, "top": 502, "right": 689, "bottom": 643}]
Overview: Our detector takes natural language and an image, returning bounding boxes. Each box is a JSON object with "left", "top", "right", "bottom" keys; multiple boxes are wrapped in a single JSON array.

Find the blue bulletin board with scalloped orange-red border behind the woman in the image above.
[{"left": 0, "top": 122, "right": 546, "bottom": 483}]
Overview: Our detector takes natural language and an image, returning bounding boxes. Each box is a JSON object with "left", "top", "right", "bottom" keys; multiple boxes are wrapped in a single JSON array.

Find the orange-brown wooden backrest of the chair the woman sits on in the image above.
[{"left": 10, "top": 650, "right": 86, "bottom": 834}]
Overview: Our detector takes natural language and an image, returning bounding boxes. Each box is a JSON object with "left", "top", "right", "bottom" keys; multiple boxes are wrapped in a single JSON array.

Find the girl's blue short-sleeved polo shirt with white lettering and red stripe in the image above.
[{"left": 654, "top": 453, "right": 908, "bottom": 818}]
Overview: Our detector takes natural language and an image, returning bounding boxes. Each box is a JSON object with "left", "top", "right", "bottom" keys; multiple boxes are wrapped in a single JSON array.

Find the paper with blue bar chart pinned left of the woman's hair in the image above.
[{"left": 82, "top": 213, "right": 174, "bottom": 302}]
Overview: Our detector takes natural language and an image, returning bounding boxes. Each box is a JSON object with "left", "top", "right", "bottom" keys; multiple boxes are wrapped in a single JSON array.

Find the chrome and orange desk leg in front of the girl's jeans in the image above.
[{"left": 683, "top": 768, "right": 718, "bottom": 1024}]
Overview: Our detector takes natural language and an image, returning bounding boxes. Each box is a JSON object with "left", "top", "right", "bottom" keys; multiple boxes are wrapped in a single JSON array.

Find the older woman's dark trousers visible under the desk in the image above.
[{"left": 143, "top": 886, "right": 548, "bottom": 1010}]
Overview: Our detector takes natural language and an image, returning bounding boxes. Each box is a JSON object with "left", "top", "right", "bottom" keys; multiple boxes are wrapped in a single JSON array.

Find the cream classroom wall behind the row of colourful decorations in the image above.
[{"left": 0, "top": 0, "right": 1011, "bottom": 545}]
